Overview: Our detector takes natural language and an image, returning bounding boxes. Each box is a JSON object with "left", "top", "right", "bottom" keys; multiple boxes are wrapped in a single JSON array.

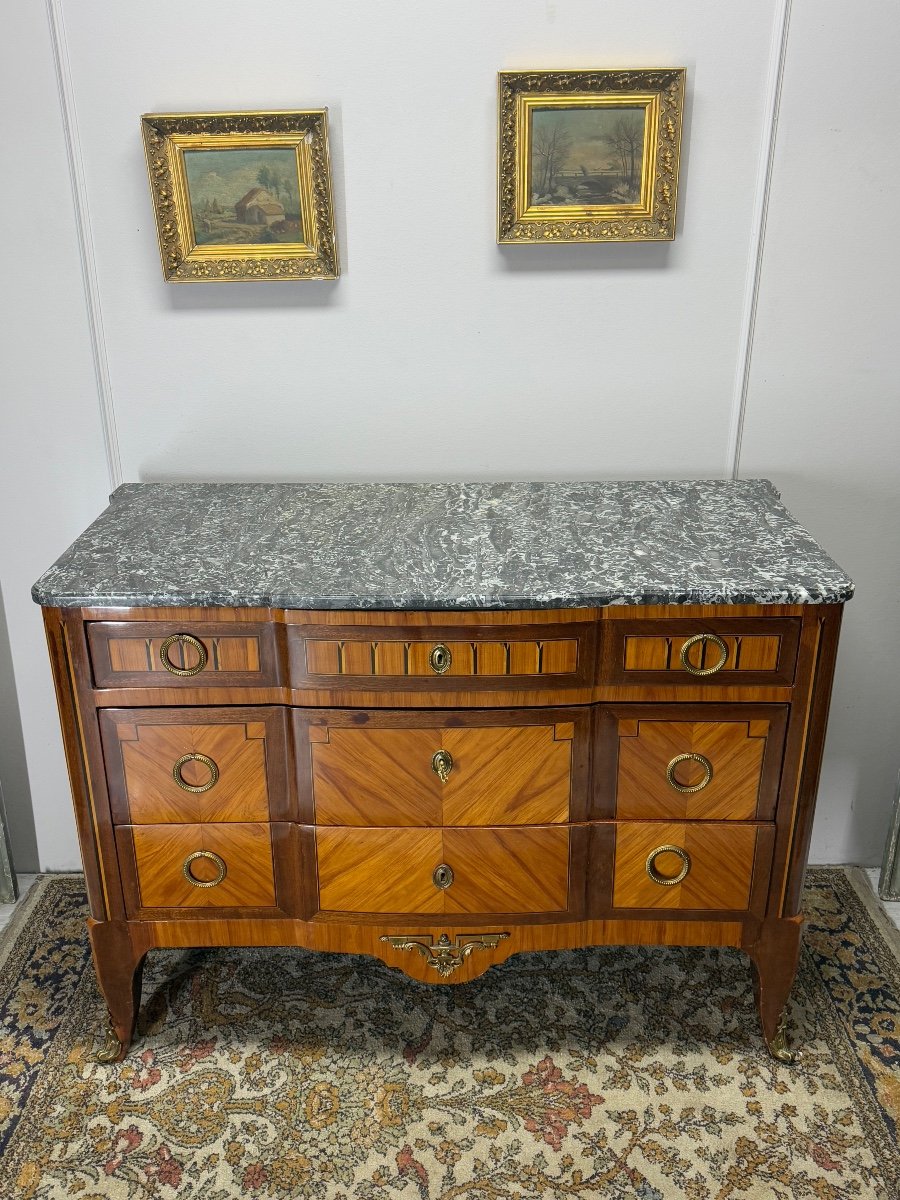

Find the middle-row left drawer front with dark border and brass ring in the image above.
[{"left": 100, "top": 708, "right": 290, "bottom": 824}]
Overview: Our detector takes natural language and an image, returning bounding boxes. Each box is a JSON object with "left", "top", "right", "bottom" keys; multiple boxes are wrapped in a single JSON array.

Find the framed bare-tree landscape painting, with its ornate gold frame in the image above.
[{"left": 497, "top": 67, "right": 685, "bottom": 245}]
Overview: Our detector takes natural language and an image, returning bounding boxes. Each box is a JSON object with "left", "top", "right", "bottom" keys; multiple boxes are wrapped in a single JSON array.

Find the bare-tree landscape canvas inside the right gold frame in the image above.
[{"left": 530, "top": 106, "right": 646, "bottom": 206}]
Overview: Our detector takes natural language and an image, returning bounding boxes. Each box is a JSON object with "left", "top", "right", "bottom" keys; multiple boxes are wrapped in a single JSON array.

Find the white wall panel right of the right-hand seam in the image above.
[{"left": 742, "top": 0, "right": 900, "bottom": 863}]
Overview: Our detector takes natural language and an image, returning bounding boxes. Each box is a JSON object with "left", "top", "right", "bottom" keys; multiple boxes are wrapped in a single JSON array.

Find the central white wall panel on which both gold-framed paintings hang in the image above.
[{"left": 66, "top": 0, "right": 773, "bottom": 479}]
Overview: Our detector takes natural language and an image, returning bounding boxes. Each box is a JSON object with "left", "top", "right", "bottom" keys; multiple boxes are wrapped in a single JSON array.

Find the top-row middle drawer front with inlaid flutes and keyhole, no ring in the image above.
[{"left": 288, "top": 622, "right": 595, "bottom": 691}]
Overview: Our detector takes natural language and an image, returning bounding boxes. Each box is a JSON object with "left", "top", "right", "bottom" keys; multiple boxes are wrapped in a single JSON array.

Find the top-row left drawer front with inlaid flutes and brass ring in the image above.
[{"left": 88, "top": 616, "right": 278, "bottom": 688}]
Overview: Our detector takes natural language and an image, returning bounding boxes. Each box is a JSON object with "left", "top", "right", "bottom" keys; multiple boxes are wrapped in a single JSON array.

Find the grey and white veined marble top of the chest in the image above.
[{"left": 32, "top": 479, "right": 853, "bottom": 608}]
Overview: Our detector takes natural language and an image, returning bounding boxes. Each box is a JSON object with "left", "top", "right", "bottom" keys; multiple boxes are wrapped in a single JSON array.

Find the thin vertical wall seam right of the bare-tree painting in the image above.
[{"left": 726, "top": 0, "right": 792, "bottom": 479}]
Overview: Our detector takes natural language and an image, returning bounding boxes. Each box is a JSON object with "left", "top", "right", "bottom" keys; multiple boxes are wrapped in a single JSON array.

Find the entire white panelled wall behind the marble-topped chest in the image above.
[{"left": 0, "top": 0, "right": 900, "bottom": 868}]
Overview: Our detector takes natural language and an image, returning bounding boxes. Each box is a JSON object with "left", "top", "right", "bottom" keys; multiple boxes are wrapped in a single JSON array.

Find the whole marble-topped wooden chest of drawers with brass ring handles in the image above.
[{"left": 35, "top": 482, "right": 852, "bottom": 1057}]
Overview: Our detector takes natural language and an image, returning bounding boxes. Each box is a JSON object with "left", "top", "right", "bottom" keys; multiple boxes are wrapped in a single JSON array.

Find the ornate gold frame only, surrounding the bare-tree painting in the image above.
[{"left": 497, "top": 67, "right": 685, "bottom": 245}]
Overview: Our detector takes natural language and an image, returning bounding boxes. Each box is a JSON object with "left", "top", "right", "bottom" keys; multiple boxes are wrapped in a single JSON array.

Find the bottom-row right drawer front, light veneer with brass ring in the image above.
[{"left": 613, "top": 821, "right": 760, "bottom": 912}]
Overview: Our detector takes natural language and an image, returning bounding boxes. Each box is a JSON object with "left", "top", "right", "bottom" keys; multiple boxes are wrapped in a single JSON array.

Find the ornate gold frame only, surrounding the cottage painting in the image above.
[{"left": 140, "top": 108, "right": 340, "bottom": 283}]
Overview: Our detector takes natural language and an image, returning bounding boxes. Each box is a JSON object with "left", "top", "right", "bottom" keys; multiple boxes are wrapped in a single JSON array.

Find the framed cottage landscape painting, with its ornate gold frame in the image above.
[{"left": 140, "top": 108, "right": 340, "bottom": 283}]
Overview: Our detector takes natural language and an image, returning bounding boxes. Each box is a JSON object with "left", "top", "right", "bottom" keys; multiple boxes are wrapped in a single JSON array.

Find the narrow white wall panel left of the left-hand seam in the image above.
[{"left": 0, "top": 0, "right": 109, "bottom": 871}]
